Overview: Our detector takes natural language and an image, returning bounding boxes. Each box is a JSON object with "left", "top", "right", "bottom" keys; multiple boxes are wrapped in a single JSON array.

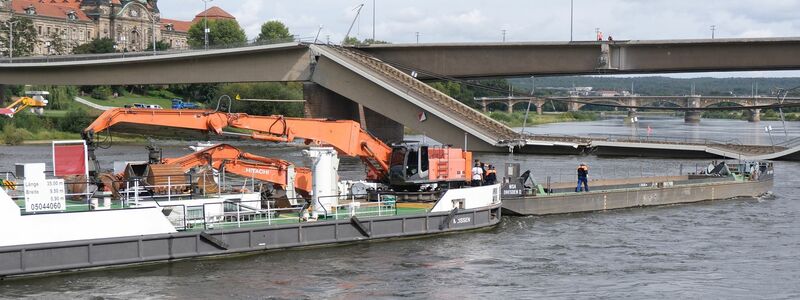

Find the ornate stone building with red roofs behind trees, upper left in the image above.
[{"left": 0, "top": 0, "right": 233, "bottom": 55}]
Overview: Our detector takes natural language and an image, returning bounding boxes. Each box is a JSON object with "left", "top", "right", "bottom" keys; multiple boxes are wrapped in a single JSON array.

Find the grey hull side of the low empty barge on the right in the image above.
[{"left": 503, "top": 178, "right": 773, "bottom": 215}]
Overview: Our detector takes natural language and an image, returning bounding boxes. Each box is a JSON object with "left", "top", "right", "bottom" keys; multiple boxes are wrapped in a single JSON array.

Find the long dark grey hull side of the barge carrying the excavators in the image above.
[{"left": 0, "top": 203, "right": 501, "bottom": 278}]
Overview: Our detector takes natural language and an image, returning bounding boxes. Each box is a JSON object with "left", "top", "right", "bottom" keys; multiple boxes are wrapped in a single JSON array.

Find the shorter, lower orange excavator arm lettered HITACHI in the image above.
[{"left": 162, "top": 144, "right": 311, "bottom": 194}]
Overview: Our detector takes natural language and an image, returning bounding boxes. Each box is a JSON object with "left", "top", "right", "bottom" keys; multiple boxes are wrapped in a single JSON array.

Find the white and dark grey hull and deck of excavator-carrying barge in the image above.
[{"left": 0, "top": 178, "right": 501, "bottom": 279}]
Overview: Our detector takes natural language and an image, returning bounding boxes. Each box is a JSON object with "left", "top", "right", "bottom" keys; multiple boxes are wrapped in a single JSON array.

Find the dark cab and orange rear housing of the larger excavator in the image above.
[{"left": 389, "top": 142, "right": 471, "bottom": 191}]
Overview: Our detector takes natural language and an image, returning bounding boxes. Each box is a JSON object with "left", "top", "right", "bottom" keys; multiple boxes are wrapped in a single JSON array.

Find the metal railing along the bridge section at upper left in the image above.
[{"left": 0, "top": 38, "right": 314, "bottom": 64}]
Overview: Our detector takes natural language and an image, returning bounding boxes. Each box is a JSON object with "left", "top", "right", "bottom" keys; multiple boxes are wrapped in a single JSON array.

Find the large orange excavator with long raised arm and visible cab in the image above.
[{"left": 82, "top": 108, "right": 472, "bottom": 190}]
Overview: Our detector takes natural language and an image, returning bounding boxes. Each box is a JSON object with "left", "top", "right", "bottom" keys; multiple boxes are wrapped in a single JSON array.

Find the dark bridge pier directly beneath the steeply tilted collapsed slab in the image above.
[{"left": 303, "top": 82, "right": 404, "bottom": 143}]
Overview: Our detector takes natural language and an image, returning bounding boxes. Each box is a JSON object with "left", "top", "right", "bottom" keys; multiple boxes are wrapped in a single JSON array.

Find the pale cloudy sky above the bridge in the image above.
[{"left": 159, "top": 0, "right": 800, "bottom": 76}]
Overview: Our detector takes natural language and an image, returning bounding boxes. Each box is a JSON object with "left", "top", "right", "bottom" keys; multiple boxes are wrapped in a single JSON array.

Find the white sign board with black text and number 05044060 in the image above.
[{"left": 25, "top": 179, "right": 67, "bottom": 213}]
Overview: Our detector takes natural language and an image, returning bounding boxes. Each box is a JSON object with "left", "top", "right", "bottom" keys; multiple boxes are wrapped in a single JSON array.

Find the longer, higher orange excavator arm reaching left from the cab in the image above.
[{"left": 83, "top": 108, "right": 392, "bottom": 179}]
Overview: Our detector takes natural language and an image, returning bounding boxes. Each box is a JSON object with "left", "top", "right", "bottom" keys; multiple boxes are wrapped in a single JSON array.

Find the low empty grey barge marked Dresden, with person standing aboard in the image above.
[{"left": 502, "top": 162, "right": 773, "bottom": 215}]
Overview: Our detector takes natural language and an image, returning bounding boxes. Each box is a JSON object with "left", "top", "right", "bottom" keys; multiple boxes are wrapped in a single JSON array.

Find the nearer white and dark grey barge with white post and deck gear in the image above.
[{"left": 0, "top": 148, "right": 501, "bottom": 279}]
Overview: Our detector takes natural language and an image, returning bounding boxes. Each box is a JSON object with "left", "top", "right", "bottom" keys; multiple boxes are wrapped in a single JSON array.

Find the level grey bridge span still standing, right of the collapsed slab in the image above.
[{"left": 360, "top": 37, "right": 800, "bottom": 78}]
